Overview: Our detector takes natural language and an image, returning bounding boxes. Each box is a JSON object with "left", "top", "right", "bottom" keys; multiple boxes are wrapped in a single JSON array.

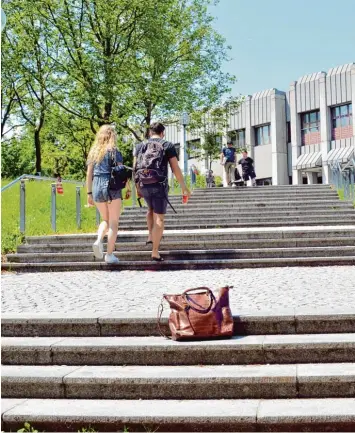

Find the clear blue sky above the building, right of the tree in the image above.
[{"left": 210, "top": 0, "right": 355, "bottom": 95}]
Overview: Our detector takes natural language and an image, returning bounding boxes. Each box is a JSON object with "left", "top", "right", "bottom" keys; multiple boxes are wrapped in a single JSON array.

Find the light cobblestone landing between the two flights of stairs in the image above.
[{"left": 1, "top": 266, "right": 355, "bottom": 314}]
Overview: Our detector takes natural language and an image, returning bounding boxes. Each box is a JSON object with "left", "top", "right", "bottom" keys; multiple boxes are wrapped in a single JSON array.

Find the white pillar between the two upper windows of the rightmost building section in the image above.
[{"left": 319, "top": 72, "right": 331, "bottom": 184}]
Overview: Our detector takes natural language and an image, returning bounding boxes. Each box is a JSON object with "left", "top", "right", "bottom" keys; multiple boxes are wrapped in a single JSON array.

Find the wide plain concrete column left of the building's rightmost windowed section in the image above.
[{"left": 271, "top": 89, "right": 288, "bottom": 185}]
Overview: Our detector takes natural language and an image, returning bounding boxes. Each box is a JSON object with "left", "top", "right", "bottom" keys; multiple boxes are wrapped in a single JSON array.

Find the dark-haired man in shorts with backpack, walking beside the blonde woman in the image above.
[{"left": 133, "top": 122, "right": 191, "bottom": 262}]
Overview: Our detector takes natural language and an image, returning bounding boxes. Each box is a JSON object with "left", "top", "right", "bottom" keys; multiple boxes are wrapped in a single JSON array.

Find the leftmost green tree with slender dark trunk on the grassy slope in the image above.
[{"left": 3, "top": 0, "right": 56, "bottom": 172}]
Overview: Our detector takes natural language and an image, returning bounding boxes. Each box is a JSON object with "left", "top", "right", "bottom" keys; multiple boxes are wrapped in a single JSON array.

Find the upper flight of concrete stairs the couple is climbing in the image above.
[{"left": 2, "top": 185, "right": 355, "bottom": 271}]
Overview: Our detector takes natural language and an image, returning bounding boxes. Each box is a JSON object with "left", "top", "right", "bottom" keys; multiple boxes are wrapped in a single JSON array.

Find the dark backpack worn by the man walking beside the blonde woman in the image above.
[{"left": 135, "top": 139, "right": 167, "bottom": 186}]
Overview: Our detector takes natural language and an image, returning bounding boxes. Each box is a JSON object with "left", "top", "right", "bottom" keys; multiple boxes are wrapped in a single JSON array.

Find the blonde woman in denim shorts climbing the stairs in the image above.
[{"left": 86, "top": 125, "right": 131, "bottom": 264}]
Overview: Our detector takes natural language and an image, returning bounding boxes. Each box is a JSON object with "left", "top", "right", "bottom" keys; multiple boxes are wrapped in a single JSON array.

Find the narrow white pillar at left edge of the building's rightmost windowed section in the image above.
[{"left": 290, "top": 81, "right": 302, "bottom": 185}]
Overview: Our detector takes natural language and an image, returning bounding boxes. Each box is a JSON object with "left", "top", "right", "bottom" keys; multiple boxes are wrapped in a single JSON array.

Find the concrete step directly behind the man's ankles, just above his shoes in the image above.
[{"left": 17, "top": 235, "right": 355, "bottom": 254}]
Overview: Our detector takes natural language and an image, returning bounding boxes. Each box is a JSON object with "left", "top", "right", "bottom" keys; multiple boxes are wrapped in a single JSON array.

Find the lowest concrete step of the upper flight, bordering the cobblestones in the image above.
[{"left": 1, "top": 256, "right": 355, "bottom": 272}]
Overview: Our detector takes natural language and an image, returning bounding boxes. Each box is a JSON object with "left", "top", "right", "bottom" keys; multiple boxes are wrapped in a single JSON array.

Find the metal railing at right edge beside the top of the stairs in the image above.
[{"left": 330, "top": 157, "right": 355, "bottom": 202}]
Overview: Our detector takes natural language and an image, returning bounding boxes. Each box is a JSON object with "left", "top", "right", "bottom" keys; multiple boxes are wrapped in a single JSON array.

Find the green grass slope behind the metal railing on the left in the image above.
[{"left": 1, "top": 181, "right": 132, "bottom": 254}]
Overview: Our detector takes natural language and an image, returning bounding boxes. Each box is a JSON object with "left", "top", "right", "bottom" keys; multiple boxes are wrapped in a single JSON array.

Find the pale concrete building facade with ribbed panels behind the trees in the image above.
[{"left": 166, "top": 63, "right": 355, "bottom": 185}]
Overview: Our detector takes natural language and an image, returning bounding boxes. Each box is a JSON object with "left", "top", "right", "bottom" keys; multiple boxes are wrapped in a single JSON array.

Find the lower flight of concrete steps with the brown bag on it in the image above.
[{"left": 2, "top": 309, "right": 355, "bottom": 432}]
